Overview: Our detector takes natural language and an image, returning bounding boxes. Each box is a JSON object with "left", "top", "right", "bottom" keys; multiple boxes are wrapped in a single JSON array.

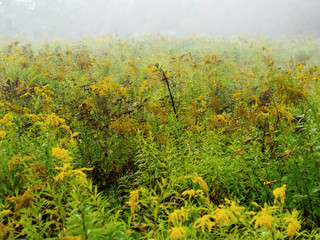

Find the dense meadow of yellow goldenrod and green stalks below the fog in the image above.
[{"left": 0, "top": 35, "right": 320, "bottom": 240}]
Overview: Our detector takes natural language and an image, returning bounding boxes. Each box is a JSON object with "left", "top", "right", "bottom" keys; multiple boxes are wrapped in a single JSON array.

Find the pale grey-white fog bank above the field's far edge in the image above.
[{"left": 0, "top": 0, "right": 320, "bottom": 39}]
